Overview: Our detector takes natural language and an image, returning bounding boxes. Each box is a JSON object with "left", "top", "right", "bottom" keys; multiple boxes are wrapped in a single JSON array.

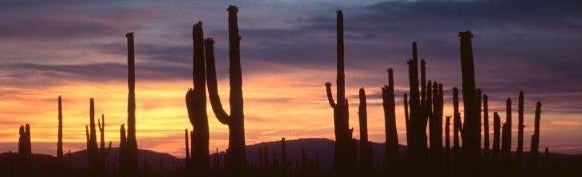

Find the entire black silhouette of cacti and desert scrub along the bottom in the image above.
[{"left": 0, "top": 6, "right": 582, "bottom": 177}]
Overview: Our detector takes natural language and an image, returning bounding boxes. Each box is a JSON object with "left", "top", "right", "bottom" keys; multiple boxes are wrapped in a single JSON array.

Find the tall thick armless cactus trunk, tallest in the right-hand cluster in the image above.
[{"left": 459, "top": 31, "right": 481, "bottom": 171}]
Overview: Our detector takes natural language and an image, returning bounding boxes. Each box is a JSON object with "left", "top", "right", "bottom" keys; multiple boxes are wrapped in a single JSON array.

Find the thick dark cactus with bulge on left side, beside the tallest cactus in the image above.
[{"left": 186, "top": 22, "right": 214, "bottom": 173}]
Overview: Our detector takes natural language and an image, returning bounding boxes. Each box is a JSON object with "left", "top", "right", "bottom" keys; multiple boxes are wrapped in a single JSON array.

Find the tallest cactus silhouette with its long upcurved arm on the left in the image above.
[{"left": 206, "top": 6, "right": 247, "bottom": 172}]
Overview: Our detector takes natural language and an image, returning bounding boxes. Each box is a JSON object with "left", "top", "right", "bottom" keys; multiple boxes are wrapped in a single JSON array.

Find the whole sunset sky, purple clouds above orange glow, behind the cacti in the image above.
[{"left": 0, "top": 0, "right": 582, "bottom": 157}]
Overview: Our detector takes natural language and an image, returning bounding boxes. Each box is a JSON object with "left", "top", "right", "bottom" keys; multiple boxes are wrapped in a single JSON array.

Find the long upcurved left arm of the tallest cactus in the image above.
[{"left": 206, "top": 38, "right": 230, "bottom": 124}]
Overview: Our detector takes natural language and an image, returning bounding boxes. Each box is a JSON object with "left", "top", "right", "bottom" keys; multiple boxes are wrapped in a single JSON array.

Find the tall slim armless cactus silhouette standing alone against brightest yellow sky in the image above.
[{"left": 125, "top": 33, "right": 137, "bottom": 172}]
